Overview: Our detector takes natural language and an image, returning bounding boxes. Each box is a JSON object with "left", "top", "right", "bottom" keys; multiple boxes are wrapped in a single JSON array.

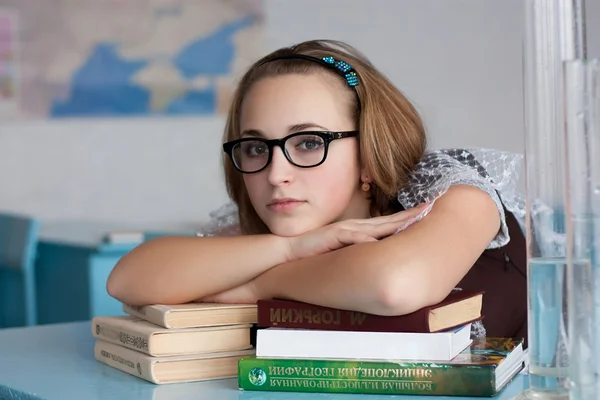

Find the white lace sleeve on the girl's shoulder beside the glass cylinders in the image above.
[{"left": 398, "top": 149, "right": 525, "bottom": 248}]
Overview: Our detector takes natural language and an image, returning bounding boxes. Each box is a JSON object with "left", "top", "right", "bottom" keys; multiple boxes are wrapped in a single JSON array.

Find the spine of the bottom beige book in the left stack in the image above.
[{"left": 94, "top": 340, "right": 158, "bottom": 384}]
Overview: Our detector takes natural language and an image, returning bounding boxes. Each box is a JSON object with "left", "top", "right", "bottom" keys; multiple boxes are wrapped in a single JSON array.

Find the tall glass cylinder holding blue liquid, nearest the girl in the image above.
[{"left": 518, "top": 0, "right": 585, "bottom": 399}]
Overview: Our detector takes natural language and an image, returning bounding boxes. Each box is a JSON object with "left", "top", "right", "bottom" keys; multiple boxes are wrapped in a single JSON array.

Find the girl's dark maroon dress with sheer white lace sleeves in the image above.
[{"left": 198, "top": 148, "right": 527, "bottom": 340}]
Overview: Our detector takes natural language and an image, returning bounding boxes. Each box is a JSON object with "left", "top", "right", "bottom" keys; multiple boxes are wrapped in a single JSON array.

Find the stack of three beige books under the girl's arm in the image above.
[{"left": 92, "top": 303, "right": 257, "bottom": 384}]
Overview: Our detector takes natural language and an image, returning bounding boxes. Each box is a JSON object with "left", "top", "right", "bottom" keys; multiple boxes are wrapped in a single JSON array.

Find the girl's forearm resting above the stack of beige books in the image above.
[{"left": 107, "top": 235, "right": 289, "bottom": 305}]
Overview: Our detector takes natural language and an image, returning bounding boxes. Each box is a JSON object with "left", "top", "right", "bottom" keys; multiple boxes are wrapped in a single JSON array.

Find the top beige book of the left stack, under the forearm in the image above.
[{"left": 123, "top": 303, "right": 257, "bottom": 328}]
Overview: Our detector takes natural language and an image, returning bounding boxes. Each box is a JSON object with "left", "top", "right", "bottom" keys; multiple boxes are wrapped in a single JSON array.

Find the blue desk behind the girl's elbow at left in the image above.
[{"left": 35, "top": 224, "right": 135, "bottom": 324}]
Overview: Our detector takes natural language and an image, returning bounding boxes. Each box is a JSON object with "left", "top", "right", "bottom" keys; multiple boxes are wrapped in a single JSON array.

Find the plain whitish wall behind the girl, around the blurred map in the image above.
[{"left": 0, "top": 0, "right": 600, "bottom": 238}]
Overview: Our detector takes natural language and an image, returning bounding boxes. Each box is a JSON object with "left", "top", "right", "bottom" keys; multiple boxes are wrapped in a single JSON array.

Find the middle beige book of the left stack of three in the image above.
[{"left": 92, "top": 315, "right": 252, "bottom": 356}]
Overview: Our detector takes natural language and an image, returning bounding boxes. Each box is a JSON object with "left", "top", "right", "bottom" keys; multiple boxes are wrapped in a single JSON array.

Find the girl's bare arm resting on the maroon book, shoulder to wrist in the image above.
[{"left": 255, "top": 186, "right": 500, "bottom": 315}]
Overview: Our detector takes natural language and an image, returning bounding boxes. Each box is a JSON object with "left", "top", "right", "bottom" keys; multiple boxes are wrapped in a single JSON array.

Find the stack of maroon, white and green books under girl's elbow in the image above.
[{"left": 238, "top": 290, "right": 524, "bottom": 396}]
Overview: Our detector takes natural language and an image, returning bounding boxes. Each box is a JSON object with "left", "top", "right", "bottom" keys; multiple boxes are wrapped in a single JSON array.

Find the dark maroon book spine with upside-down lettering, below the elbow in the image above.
[{"left": 257, "top": 300, "right": 430, "bottom": 333}]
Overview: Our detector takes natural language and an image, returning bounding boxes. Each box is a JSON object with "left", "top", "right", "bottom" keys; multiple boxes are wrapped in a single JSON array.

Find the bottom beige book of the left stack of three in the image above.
[{"left": 94, "top": 340, "right": 254, "bottom": 384}]
